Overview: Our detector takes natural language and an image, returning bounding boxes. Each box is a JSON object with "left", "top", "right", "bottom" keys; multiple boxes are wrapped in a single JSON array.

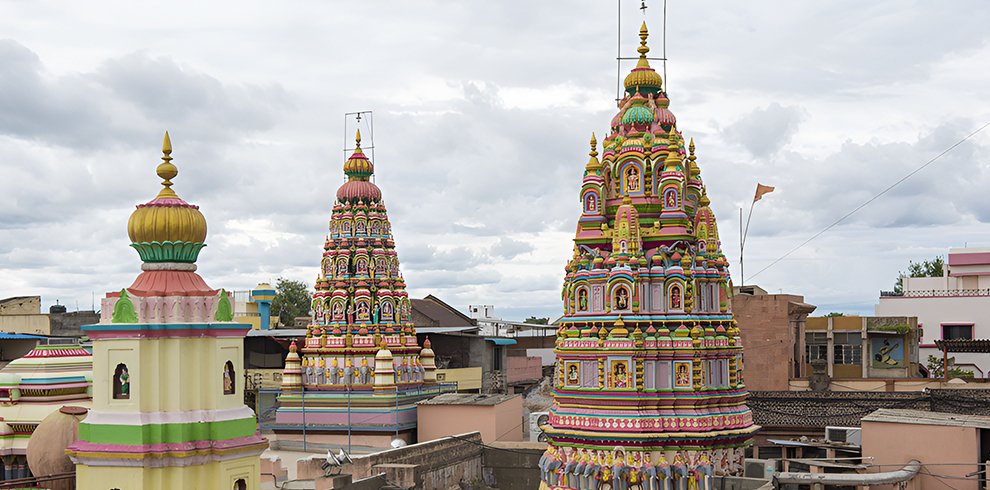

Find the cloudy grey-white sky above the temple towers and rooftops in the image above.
[{"left": 0, "top": 0, "right": 990, "bottom": 319}]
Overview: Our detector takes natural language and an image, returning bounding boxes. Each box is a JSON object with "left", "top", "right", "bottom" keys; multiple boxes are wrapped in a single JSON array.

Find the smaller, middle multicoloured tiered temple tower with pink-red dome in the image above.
[{"left": 275, "top": 131, "right": 440, "bottom": 447}]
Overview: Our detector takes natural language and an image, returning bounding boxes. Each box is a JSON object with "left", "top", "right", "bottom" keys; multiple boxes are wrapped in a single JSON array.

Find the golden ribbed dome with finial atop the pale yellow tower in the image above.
[{"left": 127, "top": 132, "right": 206, "bottom": 262}]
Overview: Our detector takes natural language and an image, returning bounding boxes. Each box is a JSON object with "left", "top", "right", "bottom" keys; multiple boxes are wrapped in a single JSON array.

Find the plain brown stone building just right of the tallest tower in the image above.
[{"left": 732, "top": 286, "right": 815, "bottom": 391}]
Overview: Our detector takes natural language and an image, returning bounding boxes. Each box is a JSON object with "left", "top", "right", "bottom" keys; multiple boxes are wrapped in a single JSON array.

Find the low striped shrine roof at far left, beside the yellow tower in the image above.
[{"left": 0, "top": 339, "right": 93, "bottom": 481}]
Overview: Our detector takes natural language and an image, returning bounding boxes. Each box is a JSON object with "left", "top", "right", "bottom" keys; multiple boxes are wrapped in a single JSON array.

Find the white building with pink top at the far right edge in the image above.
[{"left": 875, "top": 248, "right": 990, "bottom": 377}]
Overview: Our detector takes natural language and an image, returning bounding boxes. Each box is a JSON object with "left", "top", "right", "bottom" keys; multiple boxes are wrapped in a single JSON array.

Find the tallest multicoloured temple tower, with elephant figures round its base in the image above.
[{"left": 540, "top": 23, "right": 758, "bottom": 490}]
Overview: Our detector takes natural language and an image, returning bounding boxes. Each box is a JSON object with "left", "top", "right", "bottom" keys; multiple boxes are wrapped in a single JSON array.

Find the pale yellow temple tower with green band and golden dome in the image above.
[{"left": 66, "top": 133, "right": 268, "bottom": 490}]
